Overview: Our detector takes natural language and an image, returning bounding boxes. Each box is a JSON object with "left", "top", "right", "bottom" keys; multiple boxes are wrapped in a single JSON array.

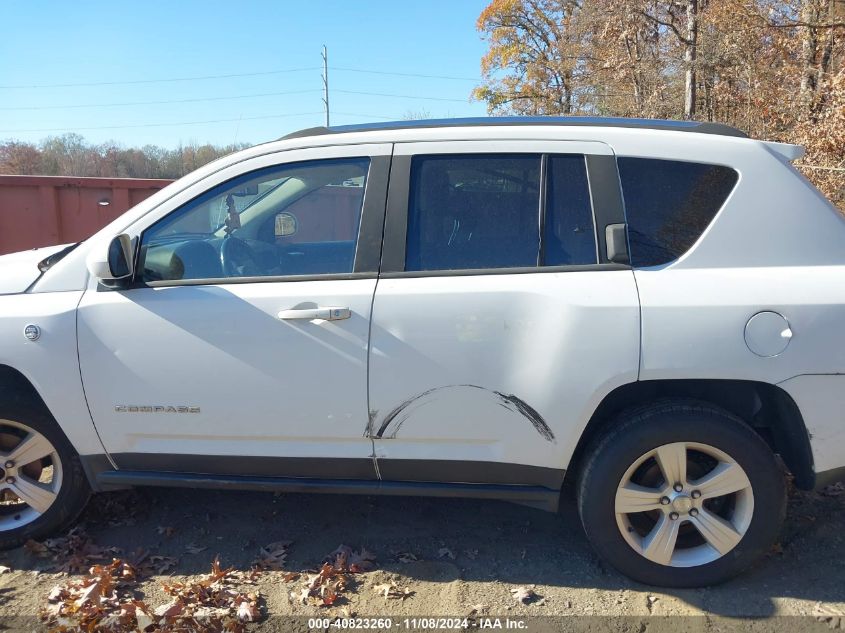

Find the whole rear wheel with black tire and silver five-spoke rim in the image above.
[{"left": 578, "top": 402, "right": 786, "bottom": 587}]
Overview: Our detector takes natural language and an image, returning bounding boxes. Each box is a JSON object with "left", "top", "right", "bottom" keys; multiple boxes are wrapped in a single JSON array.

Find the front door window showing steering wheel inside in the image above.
[{"left": 141, "top": 158, "right": 369, "bottom": 281}]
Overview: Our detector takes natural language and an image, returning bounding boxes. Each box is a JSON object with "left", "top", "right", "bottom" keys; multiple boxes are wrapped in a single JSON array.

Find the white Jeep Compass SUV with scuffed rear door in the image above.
[{"left": 0, "top": 118, "right": 845, "bottom": 586}]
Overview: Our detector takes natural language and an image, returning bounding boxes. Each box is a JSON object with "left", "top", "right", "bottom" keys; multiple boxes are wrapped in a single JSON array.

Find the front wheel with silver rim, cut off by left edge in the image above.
[{"left": 0, "top": 412, "right": 91, "bottom": 549}]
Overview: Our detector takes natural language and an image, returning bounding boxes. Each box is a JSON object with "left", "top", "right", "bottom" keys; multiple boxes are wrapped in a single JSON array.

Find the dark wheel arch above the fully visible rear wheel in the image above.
[{"left": 567, "top": 379, "right": 815, "bottom": 490}]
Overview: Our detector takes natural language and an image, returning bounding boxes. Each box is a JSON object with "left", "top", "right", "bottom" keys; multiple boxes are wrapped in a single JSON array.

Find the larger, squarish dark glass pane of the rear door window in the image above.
[{"left": 405, "top": 154, "right": 540, "bottom": 270}]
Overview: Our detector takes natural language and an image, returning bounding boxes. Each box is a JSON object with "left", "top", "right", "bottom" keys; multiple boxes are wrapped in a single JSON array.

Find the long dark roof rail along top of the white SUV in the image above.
[{"left": 279, "top": 116, "right": 748, "bottom": 141}]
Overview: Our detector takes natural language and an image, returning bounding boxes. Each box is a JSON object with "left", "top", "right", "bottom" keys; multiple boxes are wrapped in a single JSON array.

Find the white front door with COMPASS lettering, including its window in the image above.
[{"left": 78, "top": 145, "right": 390, "bottom": 479}]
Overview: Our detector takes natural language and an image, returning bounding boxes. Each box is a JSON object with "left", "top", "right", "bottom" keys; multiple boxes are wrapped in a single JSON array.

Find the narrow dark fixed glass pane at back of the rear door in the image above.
[{"left": 543, "top": 154, "right": 598, "bottom": 266}]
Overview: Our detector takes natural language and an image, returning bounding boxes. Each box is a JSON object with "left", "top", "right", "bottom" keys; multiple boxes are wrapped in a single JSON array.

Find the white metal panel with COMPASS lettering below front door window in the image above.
[{"left": 79, "top": 279, "right": 376, "bottom": 477}]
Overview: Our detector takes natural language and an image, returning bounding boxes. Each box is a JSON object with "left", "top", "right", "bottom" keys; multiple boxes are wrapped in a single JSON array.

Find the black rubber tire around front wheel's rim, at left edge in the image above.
[{"left": 0, "top": 389, "right": 91, "bottom": 550}]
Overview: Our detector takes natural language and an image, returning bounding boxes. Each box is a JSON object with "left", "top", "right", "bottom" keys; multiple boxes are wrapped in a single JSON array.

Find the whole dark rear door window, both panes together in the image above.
[{"left": 405, "top": 154, "right": 597, "bottom": 271}]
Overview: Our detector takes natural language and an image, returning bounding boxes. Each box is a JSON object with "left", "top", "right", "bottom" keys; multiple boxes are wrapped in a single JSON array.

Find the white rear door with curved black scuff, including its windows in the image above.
[{"left": 368, "top": 141, "right": 640, "bottom": 487}]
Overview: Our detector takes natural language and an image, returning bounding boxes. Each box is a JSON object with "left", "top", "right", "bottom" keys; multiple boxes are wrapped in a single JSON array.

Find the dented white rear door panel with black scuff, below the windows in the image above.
[{"left": 370, "top": 270, "right": 639, "bottom": 484}]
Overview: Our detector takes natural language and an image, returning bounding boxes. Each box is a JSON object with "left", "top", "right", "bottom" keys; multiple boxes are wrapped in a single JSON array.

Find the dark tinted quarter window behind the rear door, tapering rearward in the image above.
[{"left": 617, "top": 158, "right": 738, "bottom": 266}]
